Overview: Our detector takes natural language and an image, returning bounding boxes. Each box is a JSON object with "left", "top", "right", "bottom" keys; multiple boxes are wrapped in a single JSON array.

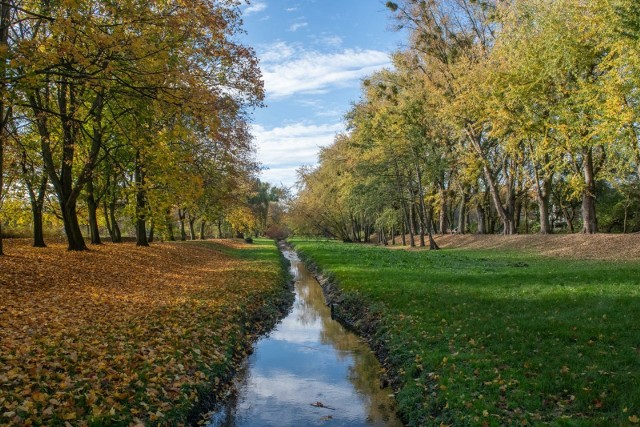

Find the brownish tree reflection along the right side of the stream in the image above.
[{"left": 297, "top": 266, "right": 402, "bottom": 426}]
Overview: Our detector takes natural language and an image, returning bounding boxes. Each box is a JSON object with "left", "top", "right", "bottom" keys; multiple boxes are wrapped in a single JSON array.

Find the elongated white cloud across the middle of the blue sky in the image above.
[{"left": 262, "top": 49, "right": 391, "bottom": 98}]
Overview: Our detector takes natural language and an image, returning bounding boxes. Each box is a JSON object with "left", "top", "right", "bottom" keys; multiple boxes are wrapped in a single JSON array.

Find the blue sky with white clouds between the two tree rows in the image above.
[{"left": 243, "top": 0, "right": 403, "bottom": 191}]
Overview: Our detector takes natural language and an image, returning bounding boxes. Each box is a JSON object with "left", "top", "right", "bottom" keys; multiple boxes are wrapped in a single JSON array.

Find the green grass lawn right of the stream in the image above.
[{"left": 292, "top": 239, "right": 640, "bottom": 426}]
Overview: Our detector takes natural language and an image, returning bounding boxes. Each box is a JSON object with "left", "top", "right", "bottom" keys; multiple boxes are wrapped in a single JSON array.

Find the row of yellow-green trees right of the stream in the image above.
[{"left": 291, "top": 0, "right": 640, "bottom": 247}]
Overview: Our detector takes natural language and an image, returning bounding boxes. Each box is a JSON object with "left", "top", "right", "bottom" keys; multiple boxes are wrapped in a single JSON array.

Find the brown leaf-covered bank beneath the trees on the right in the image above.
[{"left": 396, "top": 233, "right": 640, "bottom": 261}]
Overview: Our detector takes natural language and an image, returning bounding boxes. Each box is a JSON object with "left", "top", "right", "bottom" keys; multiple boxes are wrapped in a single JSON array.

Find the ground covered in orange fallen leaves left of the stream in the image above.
[{"left": 0, "top": 240, "right": 290, "bottom": 426}]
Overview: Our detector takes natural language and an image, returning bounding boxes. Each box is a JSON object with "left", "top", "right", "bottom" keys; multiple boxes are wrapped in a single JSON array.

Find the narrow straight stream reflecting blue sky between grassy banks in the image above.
[{"left": 209, "top": 251, "right": 402, "bottom": 427}]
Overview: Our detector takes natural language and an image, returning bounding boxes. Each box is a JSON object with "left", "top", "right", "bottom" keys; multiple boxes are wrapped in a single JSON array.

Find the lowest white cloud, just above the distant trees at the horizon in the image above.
[{"left": 252, "top": 123, "right": 344, "bottom": 186}]
